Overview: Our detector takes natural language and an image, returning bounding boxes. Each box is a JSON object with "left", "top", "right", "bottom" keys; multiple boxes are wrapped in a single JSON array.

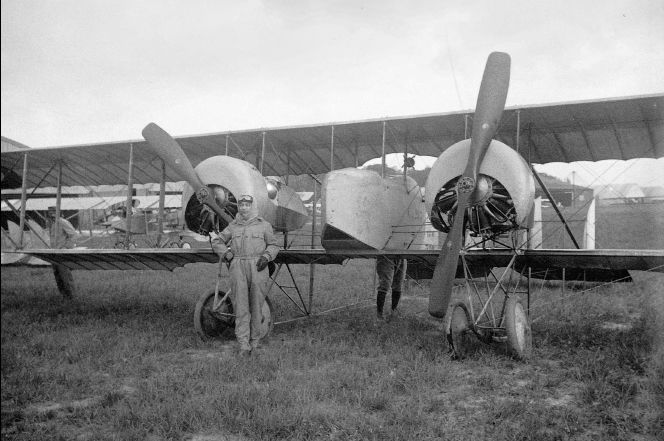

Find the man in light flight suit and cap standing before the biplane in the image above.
[{"left": 212, "top": 195, "right": 279, "bottom": 355}]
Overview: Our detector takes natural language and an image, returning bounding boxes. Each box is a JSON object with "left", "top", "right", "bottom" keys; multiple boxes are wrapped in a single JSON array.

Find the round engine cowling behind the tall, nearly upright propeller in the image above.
[{"left": 425, "top": 139, "right": 535, "bottom": 236}]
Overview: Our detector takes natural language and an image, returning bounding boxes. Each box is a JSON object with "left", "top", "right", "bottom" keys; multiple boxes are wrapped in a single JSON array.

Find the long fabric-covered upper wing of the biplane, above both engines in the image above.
[{"left": 2, "top": 94, "right": 664, "bottom": 188}]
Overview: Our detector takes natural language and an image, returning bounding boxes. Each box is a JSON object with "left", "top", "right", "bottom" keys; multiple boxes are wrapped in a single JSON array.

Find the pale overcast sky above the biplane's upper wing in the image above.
[{"left": 1, "top": 0, "right": 664, "bottom": 184}]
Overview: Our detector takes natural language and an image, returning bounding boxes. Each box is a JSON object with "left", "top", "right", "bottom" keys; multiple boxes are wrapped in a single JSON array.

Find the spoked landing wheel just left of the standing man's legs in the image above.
[{"left": 194, "top": 290, "right": 235, "bottom": 340}]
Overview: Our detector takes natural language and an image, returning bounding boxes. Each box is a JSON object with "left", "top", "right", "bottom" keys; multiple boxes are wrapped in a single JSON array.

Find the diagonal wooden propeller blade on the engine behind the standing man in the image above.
[{"left": 142, "top": 123, "right": 233, "bottom": 224}]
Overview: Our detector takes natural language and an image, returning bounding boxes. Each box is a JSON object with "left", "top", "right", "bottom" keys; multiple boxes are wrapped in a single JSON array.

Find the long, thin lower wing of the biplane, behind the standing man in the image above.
[{"left": 11, "top": 248, "right": 664, "bottom": 281}]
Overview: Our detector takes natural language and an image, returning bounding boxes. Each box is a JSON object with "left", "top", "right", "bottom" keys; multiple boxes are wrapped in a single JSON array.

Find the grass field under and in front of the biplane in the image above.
[{"left": 2, "top": 205, "right": 664, "bottom": 441}]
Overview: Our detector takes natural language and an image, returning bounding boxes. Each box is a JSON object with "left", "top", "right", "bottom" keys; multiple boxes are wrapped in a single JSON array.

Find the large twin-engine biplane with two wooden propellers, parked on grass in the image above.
[{"left": 2, "top": 53, "right": 664, "bottom": 358}]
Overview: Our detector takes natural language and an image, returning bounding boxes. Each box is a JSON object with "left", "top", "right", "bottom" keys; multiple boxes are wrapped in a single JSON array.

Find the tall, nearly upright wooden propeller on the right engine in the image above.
[{"left": 429, "top": 52, "right": 510, "bottom": 318}]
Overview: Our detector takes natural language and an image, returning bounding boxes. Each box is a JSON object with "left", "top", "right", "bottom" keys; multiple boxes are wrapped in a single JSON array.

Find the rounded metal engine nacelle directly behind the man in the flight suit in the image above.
[{"left": 182, "top": 156, "right": 308, "bottom": 234}]
